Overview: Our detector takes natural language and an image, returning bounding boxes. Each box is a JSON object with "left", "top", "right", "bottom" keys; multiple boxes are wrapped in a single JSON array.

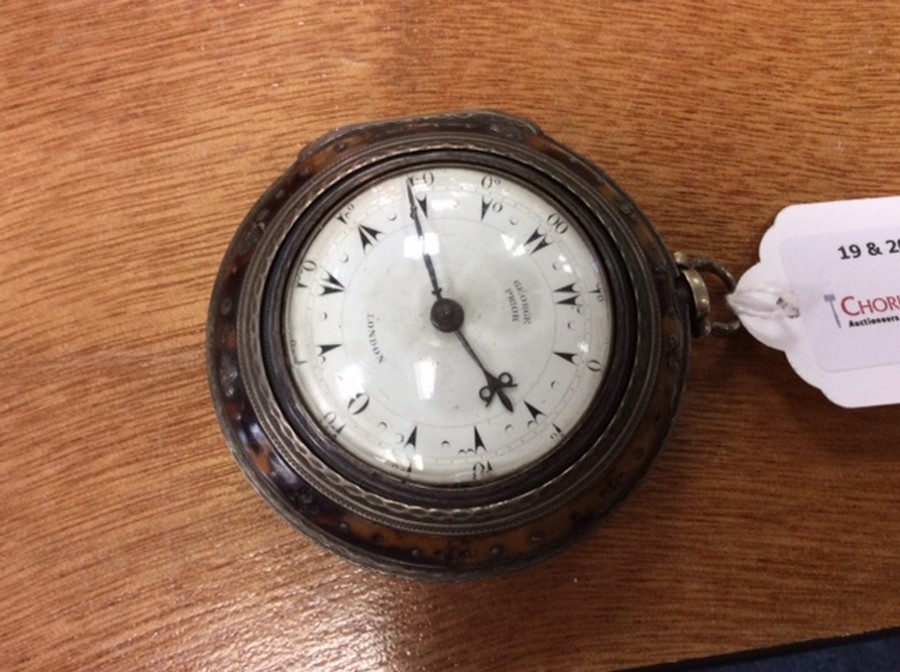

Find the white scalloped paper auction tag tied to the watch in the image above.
[{"left": 729, "top": 192, "right": 900, "bottom": 407}]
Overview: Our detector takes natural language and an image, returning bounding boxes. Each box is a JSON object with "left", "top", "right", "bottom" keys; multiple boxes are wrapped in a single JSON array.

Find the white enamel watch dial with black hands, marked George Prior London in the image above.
[{"left": 283, "top": 165, "right": 613, "bottom": 486}]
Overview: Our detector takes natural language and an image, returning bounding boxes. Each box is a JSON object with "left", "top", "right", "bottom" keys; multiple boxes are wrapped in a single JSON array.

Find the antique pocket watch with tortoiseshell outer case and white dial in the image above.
[{"left": 207, "top": 111, "right": 736, "bottom": 579}]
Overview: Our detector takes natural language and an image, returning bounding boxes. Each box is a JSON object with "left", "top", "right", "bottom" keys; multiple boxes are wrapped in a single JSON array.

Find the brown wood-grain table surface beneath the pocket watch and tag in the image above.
[{"left": 0, "top": 0, "right": 900, "bottom": 672}]
